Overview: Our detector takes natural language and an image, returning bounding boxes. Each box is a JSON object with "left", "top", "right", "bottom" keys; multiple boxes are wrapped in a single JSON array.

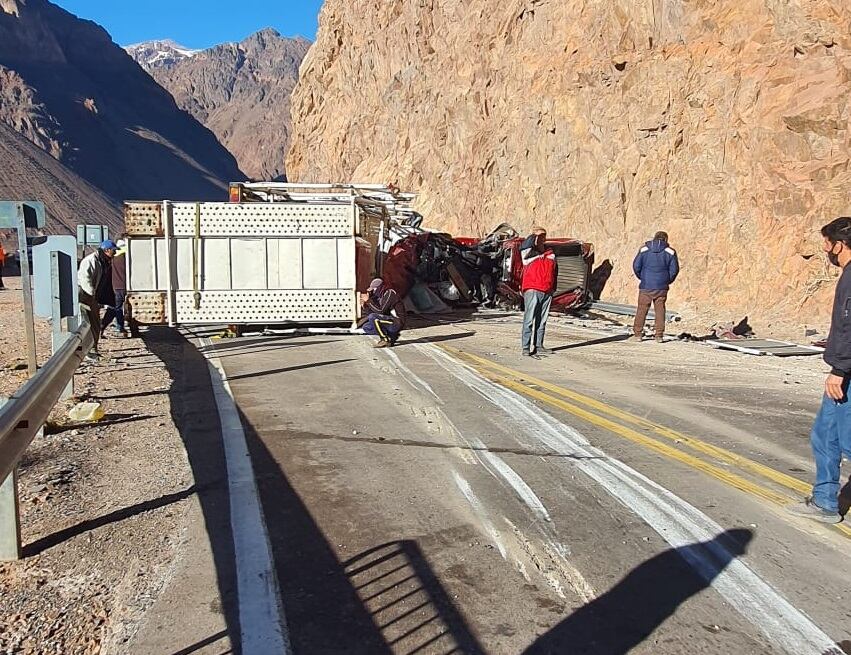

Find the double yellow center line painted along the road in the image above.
[{"left": 439, "top": 344, "right": 851, "bottom": 537}]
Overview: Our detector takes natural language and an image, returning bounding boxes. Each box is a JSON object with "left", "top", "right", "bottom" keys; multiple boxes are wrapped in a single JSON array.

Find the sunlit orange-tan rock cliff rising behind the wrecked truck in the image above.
[{"left": 287, "top": 0, "right": 851, "bottom": 324}]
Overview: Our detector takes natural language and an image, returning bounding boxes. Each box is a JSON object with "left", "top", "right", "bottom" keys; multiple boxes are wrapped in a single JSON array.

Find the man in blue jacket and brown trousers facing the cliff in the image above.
[{"left": 631, "top": 232, "right": 680, "bottom": 343}]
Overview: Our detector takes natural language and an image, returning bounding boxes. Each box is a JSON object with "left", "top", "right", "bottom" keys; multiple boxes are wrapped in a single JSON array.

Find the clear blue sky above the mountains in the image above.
[{"left": 53, "top": 0, "right": 322, "bottom": 48}]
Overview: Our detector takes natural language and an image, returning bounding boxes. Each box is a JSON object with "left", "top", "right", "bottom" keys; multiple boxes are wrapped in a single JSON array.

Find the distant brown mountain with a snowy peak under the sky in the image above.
[{"left": 137, "top": 29, "right": 310, "bottom": 180}]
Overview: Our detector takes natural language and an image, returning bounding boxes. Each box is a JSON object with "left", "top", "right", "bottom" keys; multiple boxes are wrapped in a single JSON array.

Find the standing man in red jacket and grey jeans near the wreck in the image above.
[{"left": 520, "top": 227, "right": 558, "bottom": 356}]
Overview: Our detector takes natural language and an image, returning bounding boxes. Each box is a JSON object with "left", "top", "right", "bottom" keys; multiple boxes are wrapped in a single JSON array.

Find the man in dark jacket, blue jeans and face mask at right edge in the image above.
[{"left": 790, "top": 216, "right": 851, "bottom": 523}]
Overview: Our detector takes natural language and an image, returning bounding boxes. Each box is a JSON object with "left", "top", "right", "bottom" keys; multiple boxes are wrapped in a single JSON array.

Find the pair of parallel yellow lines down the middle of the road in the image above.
[{"left": 440, "top": 345, "right": 851, "bottom": 537}]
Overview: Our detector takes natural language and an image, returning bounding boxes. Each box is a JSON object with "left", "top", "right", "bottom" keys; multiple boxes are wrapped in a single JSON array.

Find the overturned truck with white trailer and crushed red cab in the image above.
[{"left": 124, "top": 183, "right": 593, "bottom": 326}]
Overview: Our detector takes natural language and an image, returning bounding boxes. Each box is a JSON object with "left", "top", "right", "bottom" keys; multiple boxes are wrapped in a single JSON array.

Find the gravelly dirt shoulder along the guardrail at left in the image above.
[{"left": 0, "top": 278, "right": 193, "bottom": 654}]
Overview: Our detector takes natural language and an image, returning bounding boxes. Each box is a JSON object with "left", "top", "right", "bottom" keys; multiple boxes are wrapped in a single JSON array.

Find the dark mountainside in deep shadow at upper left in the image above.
[{"left": 0, "top": 0, "right": 242, "bottom": 205}]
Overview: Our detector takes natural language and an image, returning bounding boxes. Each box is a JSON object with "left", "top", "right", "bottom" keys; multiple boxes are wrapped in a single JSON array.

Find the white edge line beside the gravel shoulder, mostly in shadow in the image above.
[{"left": 200, "top": 339, "right": 292, "bottom": 655}]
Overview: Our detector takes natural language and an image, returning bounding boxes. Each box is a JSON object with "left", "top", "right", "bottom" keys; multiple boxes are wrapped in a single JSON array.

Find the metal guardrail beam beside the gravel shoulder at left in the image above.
[{"left": 0, "top": 322, "right": 94, "bottom": 483}]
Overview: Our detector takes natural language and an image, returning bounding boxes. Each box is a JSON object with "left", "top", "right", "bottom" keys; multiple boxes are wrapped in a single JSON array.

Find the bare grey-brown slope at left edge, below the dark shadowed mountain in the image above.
[{"left": 0, "top": 123, "right": 123, "bottom": 235}]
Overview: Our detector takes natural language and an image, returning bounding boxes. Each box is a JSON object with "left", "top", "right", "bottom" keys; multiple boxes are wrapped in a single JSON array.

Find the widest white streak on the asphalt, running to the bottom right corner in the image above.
[{"left": 417, "top": 345, "right": 843, "bottom": 655}]
